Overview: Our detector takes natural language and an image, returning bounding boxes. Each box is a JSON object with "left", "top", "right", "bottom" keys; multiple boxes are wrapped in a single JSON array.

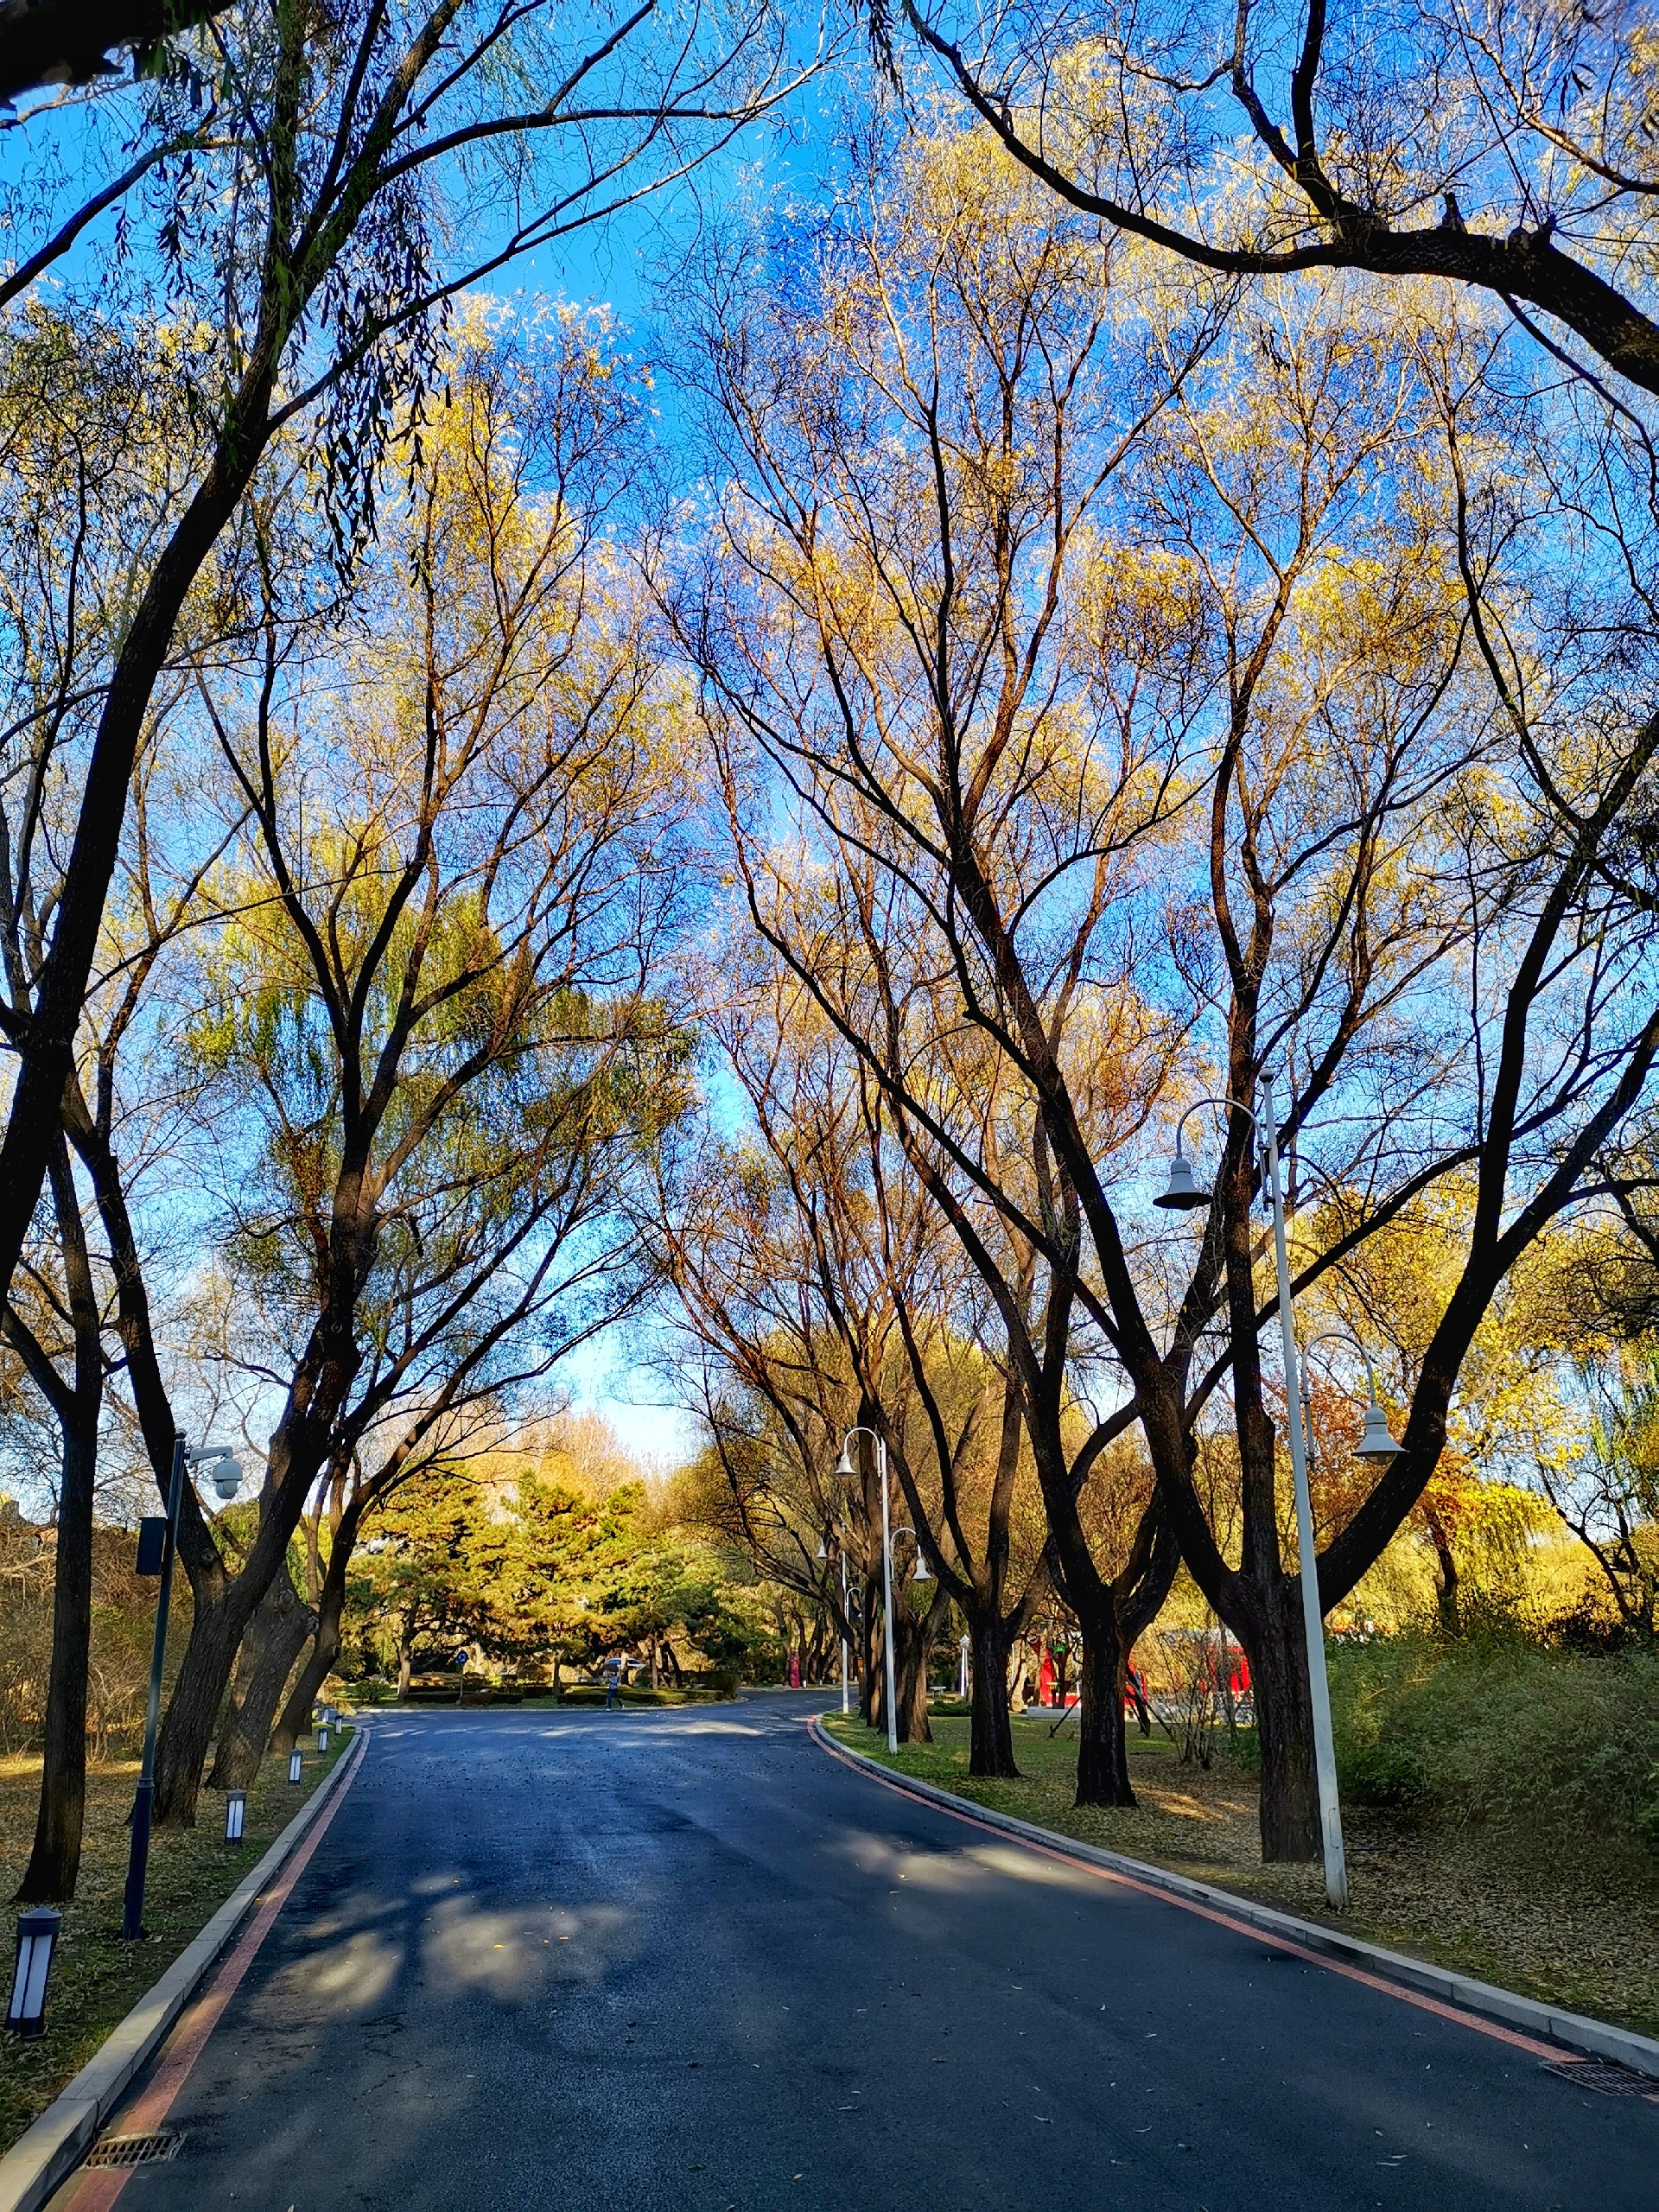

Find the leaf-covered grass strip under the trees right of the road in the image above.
[{"left": 827, "top": 1714, "right": 1659, "bottom": 2035}]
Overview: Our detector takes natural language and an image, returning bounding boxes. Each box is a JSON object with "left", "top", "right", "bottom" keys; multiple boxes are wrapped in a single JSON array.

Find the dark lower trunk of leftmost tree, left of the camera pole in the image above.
[{"left": 16, "top": 1421, "right": 98, "bottom": 1904}]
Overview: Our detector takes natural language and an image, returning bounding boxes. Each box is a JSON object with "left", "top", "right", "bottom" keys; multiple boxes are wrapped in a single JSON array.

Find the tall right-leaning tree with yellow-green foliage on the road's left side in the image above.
[{"left": 139, "top": 316, "right": 683, "bottom": 1821}]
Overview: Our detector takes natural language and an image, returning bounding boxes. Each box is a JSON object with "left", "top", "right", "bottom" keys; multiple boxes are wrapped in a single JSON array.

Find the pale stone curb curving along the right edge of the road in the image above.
[{"left": 814, "top": 1717, "right": 1659, "bottom": 2079}]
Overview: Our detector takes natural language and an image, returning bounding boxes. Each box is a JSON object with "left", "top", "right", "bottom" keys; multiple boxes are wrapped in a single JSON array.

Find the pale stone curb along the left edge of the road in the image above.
[{"left": 0, "top": 1726, "right": 370, "bottom": 2212}]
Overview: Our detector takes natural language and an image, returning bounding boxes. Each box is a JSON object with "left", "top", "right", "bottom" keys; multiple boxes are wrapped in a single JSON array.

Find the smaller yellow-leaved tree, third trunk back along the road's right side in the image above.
[{"left": 675, "top": 949, "right": 1065, "bottom": 1774}]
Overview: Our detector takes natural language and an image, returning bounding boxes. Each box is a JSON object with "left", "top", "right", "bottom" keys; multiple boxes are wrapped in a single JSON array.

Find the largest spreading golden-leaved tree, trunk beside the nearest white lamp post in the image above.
[{"left": 681, "top": 126, "right": 1659, "bottom": 1858}]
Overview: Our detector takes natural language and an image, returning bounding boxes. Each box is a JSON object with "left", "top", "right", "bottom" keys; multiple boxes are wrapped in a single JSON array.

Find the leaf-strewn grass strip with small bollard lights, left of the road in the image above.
[{"left": 0, "top": 1730, "right": 352, "bottom": 2150}]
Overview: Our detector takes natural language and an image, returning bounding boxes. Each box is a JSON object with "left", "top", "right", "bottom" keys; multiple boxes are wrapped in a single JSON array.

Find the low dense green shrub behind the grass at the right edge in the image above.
[{"left": 1330, "top": 1626, "right": 1659, "bottom": 1849}]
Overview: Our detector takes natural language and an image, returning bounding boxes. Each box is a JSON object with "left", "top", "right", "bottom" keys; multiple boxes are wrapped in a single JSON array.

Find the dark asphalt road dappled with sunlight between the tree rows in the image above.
[{"left": 61, "top": 1694, "right": 1659, "bottom": 2212}]
